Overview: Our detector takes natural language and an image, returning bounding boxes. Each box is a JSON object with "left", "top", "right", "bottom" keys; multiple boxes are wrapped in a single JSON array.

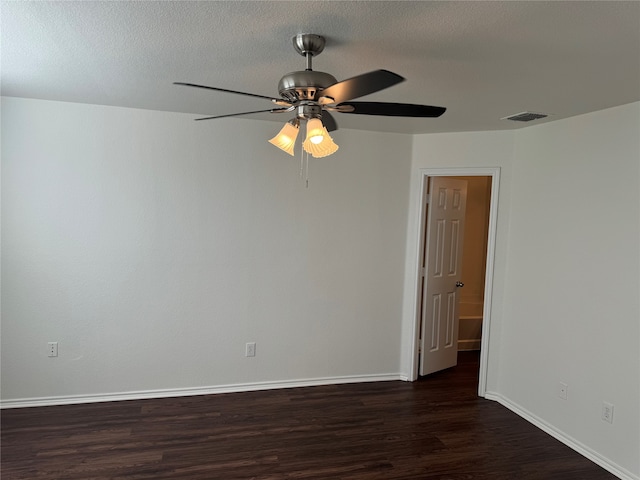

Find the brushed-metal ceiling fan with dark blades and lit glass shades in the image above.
[{"left": 174, "top": 33, "right": 446, "bottom": 157}]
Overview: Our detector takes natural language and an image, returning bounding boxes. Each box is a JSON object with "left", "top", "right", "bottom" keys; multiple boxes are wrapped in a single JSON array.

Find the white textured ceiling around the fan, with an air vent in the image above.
[{"left": 0, "top": 1, "right": 640, "bottom": 133}]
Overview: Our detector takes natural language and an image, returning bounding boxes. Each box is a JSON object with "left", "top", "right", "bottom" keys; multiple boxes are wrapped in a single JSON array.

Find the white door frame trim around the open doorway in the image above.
[{"left": 409, "top": 167, "right": 500, "bottom": 397}]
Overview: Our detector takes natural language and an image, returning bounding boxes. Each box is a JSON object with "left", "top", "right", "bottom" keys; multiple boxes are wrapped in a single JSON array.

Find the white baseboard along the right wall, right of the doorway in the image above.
[{"left": 485, "top": 392, "right": 640, "bottom": 480}]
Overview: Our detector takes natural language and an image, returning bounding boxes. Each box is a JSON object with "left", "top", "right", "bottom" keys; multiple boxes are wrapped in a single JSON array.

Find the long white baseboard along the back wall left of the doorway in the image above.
[{"left": 0, "top": 373, "right": 406, "bottom": 409}]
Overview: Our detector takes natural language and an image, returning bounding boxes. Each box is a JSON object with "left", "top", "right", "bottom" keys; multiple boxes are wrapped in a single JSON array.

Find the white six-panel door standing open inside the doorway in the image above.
[{"left": 420, "top": 177, "right": 467, "bottom": 375}]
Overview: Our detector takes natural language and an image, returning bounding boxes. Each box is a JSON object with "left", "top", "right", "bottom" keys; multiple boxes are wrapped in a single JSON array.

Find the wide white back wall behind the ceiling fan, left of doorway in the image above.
[{"left": 2, "top": 98, "right": 411, "bottom": 402}]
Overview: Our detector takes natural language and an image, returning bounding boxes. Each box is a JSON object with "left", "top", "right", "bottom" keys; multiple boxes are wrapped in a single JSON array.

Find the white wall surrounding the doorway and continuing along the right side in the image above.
[{"left": 403, "top": 103, "right": 640, "bottom": 479}]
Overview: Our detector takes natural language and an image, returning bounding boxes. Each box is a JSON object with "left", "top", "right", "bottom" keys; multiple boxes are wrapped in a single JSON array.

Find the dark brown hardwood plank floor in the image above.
[{"left": 1, "top": 353, "right": 616, "bottom": 480}]
